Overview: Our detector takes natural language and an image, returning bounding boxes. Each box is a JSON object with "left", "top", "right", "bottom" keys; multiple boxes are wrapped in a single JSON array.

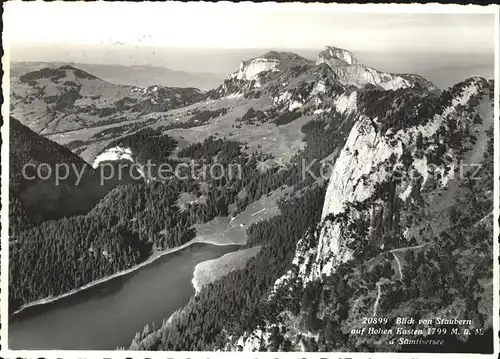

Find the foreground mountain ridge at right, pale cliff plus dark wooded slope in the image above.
[{"left": 229, "top": 77, "right": 493, "bottom": 351}]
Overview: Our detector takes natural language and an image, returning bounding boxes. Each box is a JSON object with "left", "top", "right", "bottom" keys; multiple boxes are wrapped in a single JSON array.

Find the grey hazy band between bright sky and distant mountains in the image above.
[{"left": 10, "top": 44, "right": 495, "bottom": 88}]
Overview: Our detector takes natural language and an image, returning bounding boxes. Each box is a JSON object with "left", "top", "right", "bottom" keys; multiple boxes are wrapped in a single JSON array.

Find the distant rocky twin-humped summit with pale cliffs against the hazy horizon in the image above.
[{"left": 208, "top": 46, "right": 439, "bottom": 99}]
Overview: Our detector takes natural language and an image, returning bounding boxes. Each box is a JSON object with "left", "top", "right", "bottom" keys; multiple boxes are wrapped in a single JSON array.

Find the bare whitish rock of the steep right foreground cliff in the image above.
[{"left": 275, "top": 84, "right": 478, "bottom": 288}]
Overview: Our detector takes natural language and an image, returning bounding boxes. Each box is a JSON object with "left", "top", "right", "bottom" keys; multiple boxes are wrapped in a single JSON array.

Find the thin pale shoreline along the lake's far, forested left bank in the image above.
[{"left": 9, "top": 239, "right": 242, "bottom": 321}]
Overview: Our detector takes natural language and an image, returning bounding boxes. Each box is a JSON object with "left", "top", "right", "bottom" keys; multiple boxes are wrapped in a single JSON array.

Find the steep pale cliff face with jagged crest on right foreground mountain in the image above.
[{"left": 296, "top": 78, "right": 490, "bottom": 281}]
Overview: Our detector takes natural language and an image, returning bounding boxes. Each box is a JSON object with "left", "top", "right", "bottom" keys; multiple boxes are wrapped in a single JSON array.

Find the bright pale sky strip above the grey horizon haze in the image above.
[{"left": 4, "top": 2, "right": 494, "bottom": 53}]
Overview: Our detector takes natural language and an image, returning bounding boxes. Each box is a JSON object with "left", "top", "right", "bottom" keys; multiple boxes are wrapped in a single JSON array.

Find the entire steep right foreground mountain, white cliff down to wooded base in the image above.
[{"left": 233, "top": 78, "right": 493, "bottom": 351}]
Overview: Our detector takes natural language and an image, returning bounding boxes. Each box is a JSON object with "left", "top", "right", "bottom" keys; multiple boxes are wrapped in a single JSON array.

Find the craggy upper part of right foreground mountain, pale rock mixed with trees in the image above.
[{"left": 286, "top": 77, "right": 492, "bottom": 279}]
